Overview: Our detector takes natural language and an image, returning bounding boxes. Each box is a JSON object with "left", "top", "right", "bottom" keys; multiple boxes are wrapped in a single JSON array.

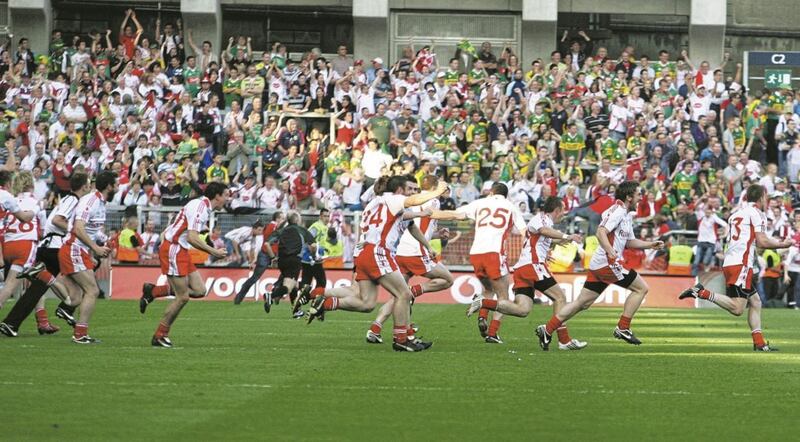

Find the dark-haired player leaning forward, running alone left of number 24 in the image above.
[{"left": 151, "top": 183, "right": 229, "bottom": 348}]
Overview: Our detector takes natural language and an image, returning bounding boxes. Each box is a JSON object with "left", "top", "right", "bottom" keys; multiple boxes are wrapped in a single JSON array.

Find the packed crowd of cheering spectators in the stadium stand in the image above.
[{"left": 0, "top": 10, "right": 800, "bottom": 305}]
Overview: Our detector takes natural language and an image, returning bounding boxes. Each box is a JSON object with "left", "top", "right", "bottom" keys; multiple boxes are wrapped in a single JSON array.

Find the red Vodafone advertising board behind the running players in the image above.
[{"left": 110, "top": 266, "right": 695, "bottom": 308}]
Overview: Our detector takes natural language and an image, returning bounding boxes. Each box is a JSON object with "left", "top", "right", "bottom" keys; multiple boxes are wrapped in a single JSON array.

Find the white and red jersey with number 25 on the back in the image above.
[{"left": 456, "top": 195, "right": 525, "bottom": 255}]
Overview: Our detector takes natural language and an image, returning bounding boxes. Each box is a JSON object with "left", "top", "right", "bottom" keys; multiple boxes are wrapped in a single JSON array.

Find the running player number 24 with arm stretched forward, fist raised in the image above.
[{"left": 309, "top": 176, "right": 447, "bottom": 352}]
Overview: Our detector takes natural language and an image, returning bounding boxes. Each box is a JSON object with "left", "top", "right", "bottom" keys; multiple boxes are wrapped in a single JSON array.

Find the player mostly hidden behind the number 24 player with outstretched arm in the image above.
[{"left": 367, "top": 175, "right": 454, "bottom": 344}]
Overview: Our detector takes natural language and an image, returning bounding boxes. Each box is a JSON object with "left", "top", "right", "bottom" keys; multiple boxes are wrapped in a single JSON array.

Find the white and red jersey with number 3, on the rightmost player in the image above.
[{"left": 722, "top": 203, "right": 767, "bottom": 268}]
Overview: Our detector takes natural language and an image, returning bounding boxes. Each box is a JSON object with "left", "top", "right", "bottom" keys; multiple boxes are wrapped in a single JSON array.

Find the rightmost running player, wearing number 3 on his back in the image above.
[{"left": 678, "top": 184, "right": 794, "bottom": 351}]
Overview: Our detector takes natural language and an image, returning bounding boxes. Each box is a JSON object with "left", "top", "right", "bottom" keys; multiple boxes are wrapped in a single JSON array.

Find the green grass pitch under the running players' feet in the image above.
[{"left": 0, "top": 301, "right": 800, "bottom": 441}]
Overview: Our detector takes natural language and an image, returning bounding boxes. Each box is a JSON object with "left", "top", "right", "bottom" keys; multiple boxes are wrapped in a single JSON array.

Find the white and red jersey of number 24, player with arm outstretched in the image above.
[{"left": 356, "top": 192, "right": 408, "bottom": 256}]
